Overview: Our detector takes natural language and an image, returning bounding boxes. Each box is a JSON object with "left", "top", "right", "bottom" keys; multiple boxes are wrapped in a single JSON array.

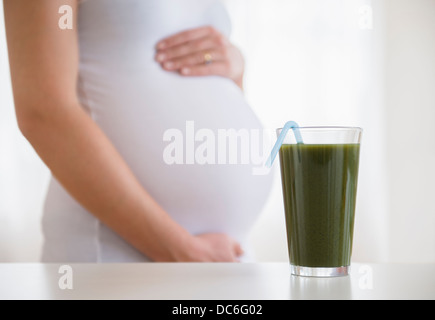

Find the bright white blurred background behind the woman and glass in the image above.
[{"left": 0, "top": 0, "right": 435, "bottom": 262}]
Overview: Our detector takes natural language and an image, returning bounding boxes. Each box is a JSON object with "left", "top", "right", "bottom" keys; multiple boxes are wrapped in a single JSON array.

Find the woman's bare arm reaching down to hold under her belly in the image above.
[{"left": 4, "top": 0, "right": 242, "bottom": 261}]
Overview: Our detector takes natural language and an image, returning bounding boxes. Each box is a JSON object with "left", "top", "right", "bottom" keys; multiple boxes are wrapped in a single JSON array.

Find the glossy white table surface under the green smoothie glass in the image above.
[{"left": 0, "top": 263, "right": 435, "bottom": 300}]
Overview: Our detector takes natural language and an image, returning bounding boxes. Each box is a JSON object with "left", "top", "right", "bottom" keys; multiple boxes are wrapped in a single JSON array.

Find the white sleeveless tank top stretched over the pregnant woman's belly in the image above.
[{"left": 42, "top": 0, "right": 272, "bottom": 262}]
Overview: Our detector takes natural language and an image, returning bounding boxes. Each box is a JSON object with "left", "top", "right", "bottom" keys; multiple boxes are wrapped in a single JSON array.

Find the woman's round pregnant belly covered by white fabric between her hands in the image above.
[{"left": 81, "top": 70, "right": 272, "bottom": 238}]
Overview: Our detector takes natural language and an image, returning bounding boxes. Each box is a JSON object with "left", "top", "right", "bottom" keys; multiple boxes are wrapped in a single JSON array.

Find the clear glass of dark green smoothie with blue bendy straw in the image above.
[{"left": 277, "top": 127, "right": 362, "bottom": 277}]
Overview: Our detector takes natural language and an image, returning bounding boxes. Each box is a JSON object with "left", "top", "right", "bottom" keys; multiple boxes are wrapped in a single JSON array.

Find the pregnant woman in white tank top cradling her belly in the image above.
[{"left": 4, "top": 0, "right": 271, "bottom": 262}]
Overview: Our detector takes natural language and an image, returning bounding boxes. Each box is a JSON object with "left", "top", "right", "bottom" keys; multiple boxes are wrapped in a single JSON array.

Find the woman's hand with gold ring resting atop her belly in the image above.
[{"left": 156, "top": 26, "right": 245, "bottom": 88}]
